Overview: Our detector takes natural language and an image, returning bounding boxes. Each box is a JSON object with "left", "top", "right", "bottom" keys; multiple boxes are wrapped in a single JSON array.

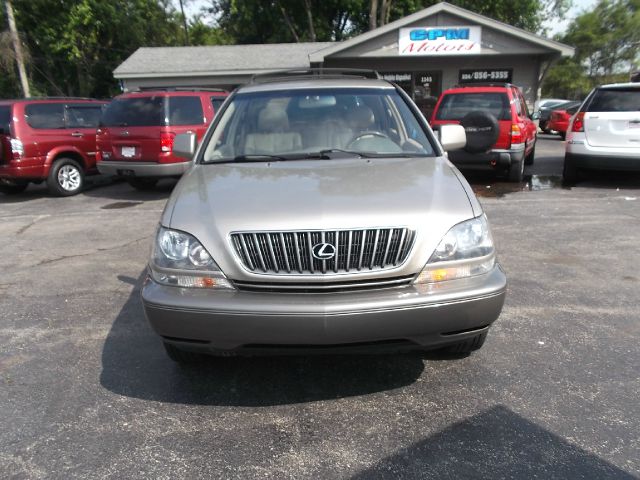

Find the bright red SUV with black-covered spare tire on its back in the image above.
[{"left": 431, "top": 84, "right": 537, "bottom": 182}]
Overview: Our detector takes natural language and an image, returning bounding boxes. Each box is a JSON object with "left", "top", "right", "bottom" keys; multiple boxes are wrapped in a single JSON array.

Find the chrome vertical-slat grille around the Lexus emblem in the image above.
[{"left": 231, "top": 228, "right": 415, "bottom": 275}]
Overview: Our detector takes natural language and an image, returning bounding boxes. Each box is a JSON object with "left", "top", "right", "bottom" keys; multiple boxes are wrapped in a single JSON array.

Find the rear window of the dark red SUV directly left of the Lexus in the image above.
[{"left": 101, "top": 96, "right": 167, "bottom": 127}]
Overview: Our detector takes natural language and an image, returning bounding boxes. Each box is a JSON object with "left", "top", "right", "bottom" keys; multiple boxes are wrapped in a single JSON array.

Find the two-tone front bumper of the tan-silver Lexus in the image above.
[{"left": 142, "top": 266, "right": 506, "bottom": 353}]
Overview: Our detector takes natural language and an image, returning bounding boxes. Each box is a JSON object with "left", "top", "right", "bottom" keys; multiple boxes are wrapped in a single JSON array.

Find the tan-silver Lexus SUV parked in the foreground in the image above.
[{"left": 142, "top": 70, "right": 506, "bottom": 361}]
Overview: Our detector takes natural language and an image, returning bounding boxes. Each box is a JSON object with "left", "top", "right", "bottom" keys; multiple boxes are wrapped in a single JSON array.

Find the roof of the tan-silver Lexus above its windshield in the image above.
[{"left": 237, "top": 76, "right": 395, "bottom": 93}]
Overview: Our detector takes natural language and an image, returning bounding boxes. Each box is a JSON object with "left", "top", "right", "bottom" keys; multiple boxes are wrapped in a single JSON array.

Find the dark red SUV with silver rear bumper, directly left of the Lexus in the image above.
[{"left": 97, "top": 88, "right": 228, "bottom": 190}]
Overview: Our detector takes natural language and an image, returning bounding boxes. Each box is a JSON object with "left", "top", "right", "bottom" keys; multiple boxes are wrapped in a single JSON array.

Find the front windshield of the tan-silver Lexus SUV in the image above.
[{"left": 202, "top": 88, "right": 434, "bottom": 162}]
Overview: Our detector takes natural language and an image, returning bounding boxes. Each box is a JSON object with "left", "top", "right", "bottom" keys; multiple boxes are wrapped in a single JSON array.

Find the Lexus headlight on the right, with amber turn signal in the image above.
[{"left": 414, "top": 215, "right": 495, "bottom": 283}]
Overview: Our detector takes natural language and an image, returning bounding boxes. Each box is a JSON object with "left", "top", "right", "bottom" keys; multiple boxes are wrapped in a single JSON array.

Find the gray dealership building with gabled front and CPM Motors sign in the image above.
[{"left": 114, "top": 2, "right": 574, "bottom": 112}]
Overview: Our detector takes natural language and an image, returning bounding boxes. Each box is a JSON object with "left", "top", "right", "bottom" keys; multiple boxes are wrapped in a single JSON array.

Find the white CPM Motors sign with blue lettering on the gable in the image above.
[{"left": 398, "top": 27, "right": 482, "bottom": 55}]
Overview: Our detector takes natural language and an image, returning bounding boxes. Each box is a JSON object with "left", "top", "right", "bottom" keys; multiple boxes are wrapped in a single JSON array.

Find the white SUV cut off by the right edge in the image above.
[{"left": 563, "top": 83, "right": 640, "bottom": 183}]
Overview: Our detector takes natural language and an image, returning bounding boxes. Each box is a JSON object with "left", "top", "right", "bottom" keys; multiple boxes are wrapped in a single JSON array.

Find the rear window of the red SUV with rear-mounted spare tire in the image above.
[{"left": 436, "top": 92, "right": 511, "bottom": 120}]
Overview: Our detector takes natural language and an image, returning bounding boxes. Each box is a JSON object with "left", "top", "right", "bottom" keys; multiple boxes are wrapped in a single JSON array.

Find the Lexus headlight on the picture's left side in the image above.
[{"left": 149, "top": 227, "right": 234, "bottom": 289}]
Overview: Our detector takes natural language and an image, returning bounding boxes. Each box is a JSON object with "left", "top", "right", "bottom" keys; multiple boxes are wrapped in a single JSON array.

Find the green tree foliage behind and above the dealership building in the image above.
[{"left": 0, "top": 0, "right": 608, "bottom": 97}]
